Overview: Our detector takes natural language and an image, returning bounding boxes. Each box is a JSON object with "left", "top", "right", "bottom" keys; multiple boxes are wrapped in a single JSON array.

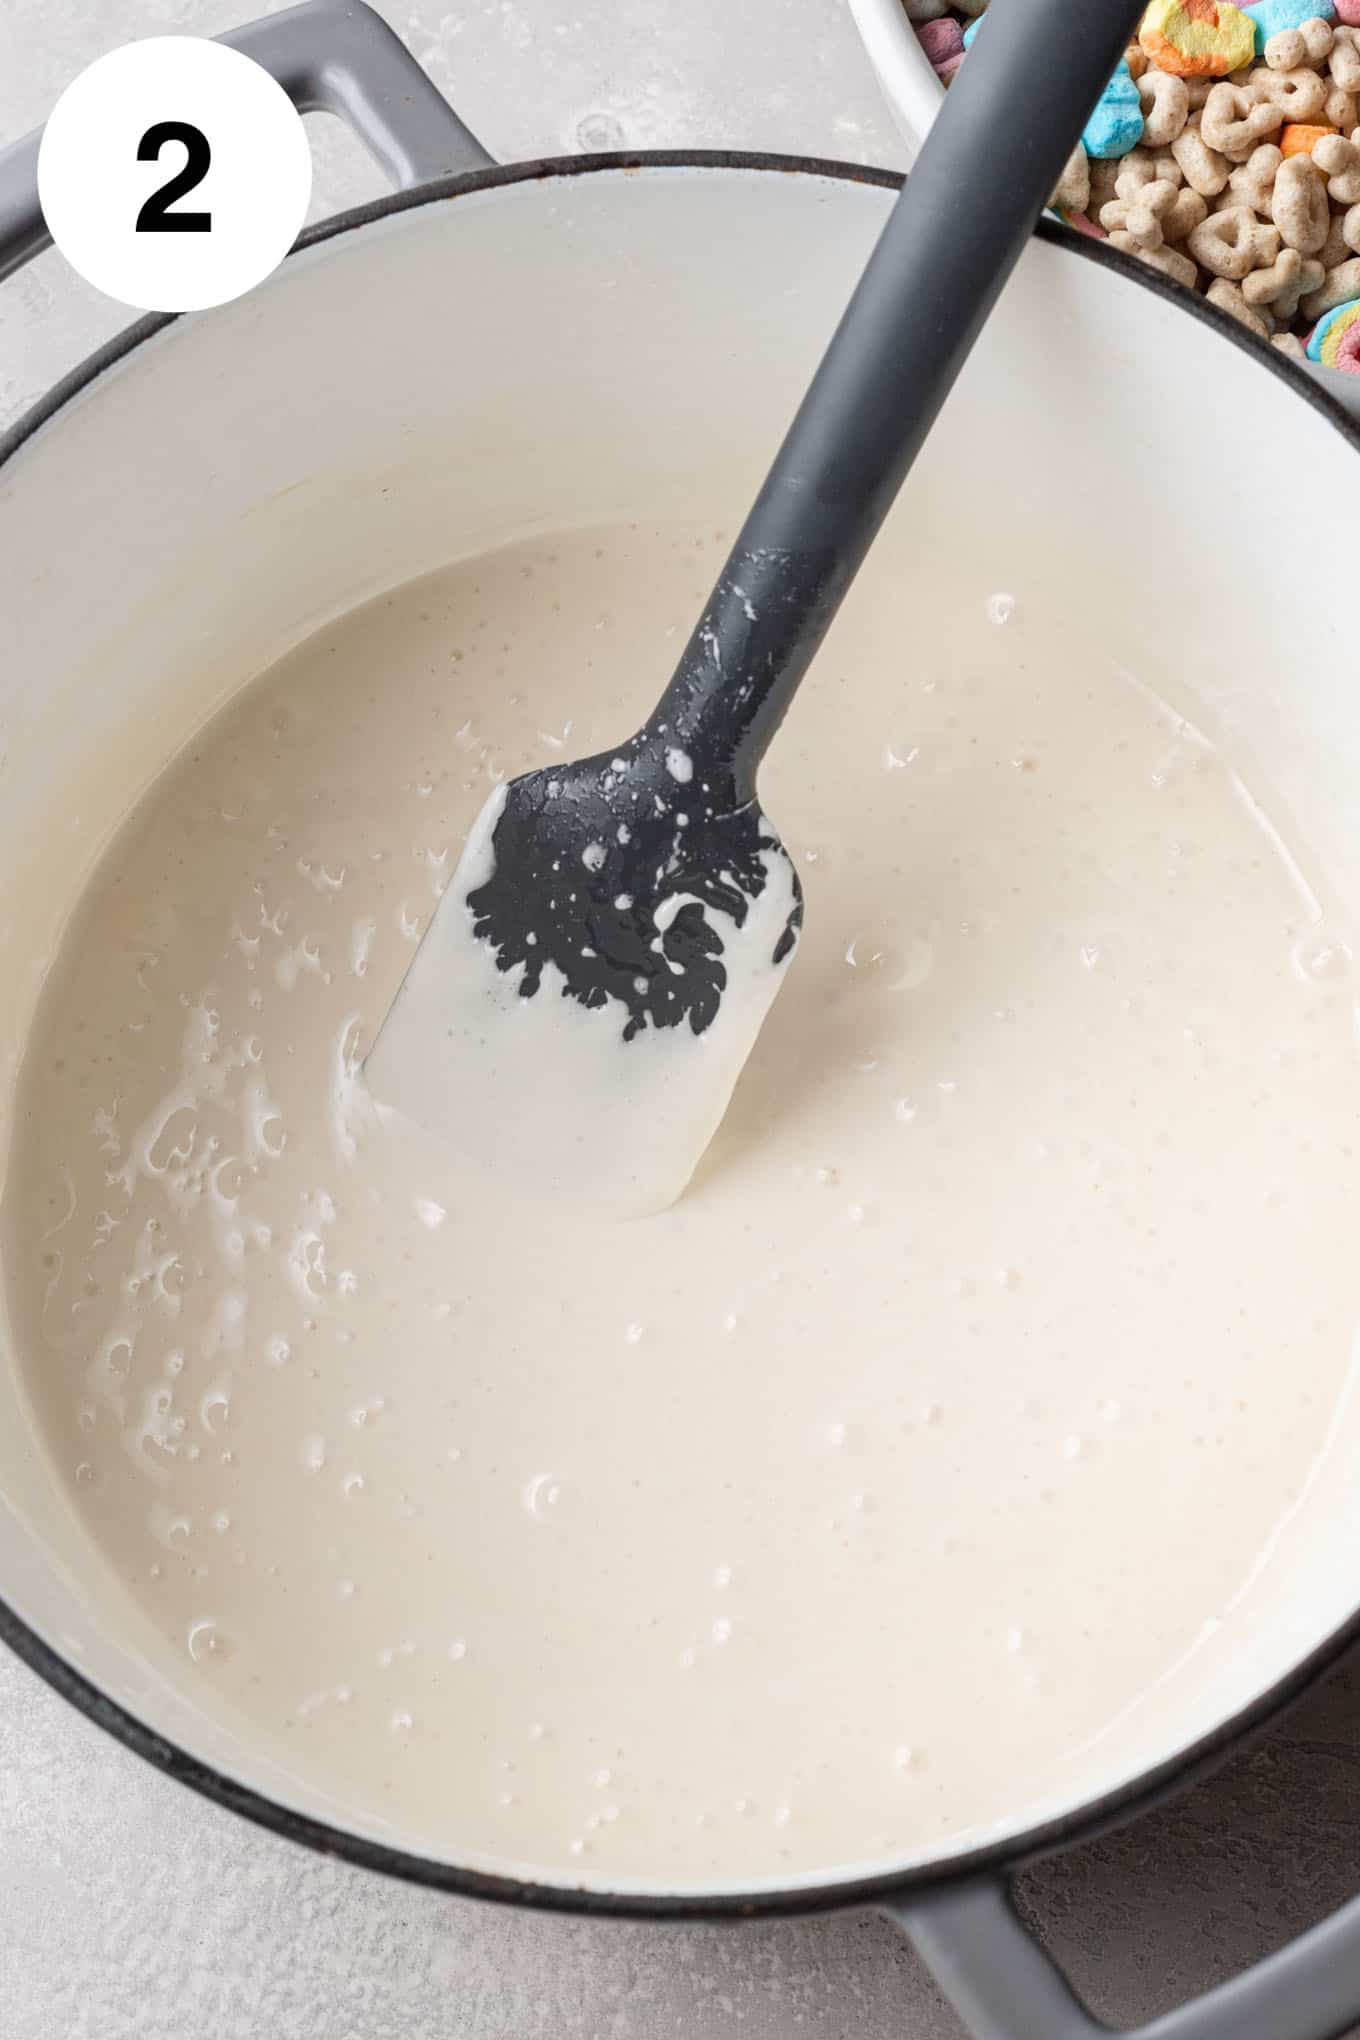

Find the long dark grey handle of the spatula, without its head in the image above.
[{"left": 655, "top": 0, "right": 1142, "bottom": 796}]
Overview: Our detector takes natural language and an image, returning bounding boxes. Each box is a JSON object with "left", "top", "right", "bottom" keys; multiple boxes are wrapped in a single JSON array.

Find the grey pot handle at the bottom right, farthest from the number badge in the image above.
[{"left": 883, "top": 1877, "right": 1360, "bottom": 2040}]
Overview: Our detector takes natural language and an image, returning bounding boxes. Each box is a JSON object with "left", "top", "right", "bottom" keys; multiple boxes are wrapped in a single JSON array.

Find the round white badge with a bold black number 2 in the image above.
[{"left": 39, "top": 35, "right": 312, "bottom": 312}]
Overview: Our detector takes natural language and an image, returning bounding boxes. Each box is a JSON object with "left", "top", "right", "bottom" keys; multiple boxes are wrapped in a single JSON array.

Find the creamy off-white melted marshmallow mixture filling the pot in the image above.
[{"left": 4, "top": 528, "right": 1360, "bottom": 1887}]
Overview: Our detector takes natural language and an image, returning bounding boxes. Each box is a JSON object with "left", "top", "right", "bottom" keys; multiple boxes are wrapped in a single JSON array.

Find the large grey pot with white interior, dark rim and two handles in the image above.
[{"left": 0, "top": 0, "right": 1360, "bottom": 2040}]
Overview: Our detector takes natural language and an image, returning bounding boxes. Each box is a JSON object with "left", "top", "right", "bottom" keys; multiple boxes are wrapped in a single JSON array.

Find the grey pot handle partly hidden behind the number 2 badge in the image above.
[{"left": 0, "top": 0, "right": 493, "bottom": 282}]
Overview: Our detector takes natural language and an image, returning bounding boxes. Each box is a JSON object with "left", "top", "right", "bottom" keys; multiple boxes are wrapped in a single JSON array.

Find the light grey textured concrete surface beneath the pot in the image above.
[{"left": 0, "top": 0, "right": 1360, "bottom": 2040}]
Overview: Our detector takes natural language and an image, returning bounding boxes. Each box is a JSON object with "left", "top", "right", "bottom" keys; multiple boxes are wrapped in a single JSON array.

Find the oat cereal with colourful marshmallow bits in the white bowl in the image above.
[{"left": 903, "top": 0, "right": 1360, "bottom": 375}]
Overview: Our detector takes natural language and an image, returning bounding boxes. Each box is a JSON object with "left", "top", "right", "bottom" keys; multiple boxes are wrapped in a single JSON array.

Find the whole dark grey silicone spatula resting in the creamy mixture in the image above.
[{"left": 367, "top": 0, "right": 1142, "bottom": 1210}]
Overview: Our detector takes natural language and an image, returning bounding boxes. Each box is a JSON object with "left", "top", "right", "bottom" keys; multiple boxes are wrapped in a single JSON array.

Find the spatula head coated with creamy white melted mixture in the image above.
[{"left": 367, "top": 732, "right": 803, "bottom": 1214}]
